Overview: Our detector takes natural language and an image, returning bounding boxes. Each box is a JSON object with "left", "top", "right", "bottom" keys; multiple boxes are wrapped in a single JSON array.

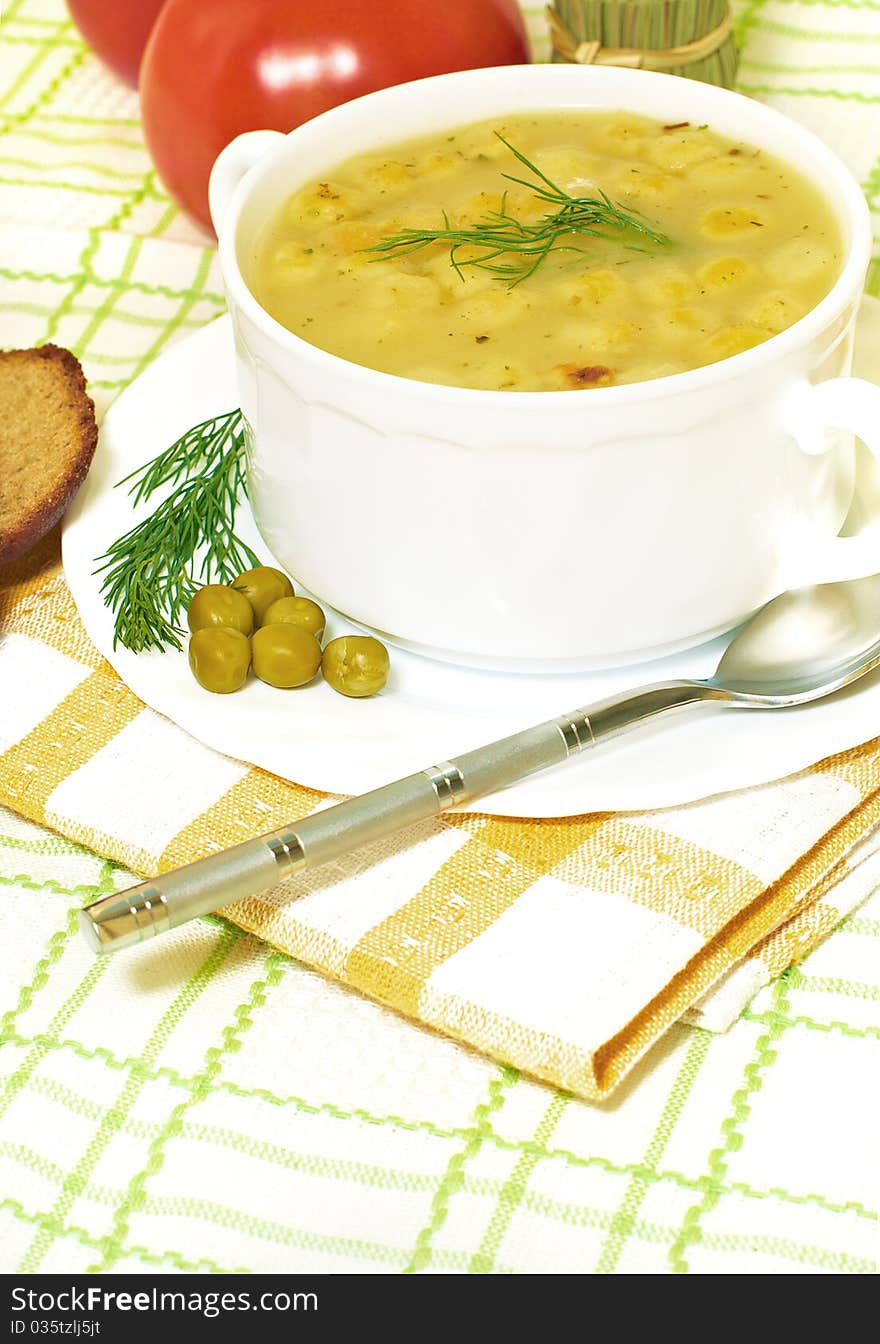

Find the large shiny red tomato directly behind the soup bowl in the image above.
[{"left": 141, "top": 0, "right": 528, "bottom": 227}]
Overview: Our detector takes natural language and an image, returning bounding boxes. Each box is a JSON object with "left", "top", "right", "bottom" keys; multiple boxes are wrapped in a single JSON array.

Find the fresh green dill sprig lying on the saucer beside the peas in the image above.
[{"left": 94, "top": 410, "right": 259, "bottom": 653}]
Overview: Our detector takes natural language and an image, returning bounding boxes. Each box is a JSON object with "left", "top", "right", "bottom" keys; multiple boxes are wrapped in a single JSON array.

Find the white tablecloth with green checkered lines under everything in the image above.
[{"left": 0, "top": 0, "right": 880, "bottom": 1273}]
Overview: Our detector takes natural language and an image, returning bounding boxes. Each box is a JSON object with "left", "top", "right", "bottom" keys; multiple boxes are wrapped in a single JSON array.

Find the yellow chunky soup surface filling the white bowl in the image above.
[{"left": 249, "top": 112, "right": 842, "bottom": 391}]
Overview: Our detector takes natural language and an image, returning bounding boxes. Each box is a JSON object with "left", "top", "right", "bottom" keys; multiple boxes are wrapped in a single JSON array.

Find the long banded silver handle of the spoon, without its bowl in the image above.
[{"left": 79, "top": 681, "right": 709, "bottom": 952}]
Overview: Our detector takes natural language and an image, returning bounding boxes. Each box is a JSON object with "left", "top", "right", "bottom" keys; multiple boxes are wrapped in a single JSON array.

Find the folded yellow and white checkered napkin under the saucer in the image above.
[{"left": 0, "top": 526, "right": 880, "bottom": 1098}]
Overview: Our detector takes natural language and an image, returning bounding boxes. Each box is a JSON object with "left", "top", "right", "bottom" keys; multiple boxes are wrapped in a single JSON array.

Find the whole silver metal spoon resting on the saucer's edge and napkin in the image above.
[{"left": 79, "top": 575, "right": 880, "bottom": 952}]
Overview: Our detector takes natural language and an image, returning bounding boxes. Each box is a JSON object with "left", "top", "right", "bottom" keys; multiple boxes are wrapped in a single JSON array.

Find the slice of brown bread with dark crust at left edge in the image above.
[{"left": 0, "top": 345, "right": 98, "bottom": 564}]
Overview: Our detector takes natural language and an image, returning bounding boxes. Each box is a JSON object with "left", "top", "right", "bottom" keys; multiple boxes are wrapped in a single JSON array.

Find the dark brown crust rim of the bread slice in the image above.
[{"left": 0, "top": 344, "right": 98, "bottom": 564}]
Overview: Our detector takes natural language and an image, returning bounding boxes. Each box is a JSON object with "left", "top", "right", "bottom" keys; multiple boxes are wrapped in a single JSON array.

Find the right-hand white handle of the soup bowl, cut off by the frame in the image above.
[{"left": 782, "top": 378, "right": 880, "bottom": 589}]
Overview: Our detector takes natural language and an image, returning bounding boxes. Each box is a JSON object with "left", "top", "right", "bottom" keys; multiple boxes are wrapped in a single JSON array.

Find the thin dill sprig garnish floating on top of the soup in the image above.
[{"left": 364, "top": 130, "right": 669, "bottom": 289}]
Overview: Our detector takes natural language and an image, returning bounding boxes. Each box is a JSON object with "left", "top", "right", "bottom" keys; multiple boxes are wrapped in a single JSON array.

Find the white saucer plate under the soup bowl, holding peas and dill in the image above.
[{"left": 63, "top": 300, "right": 880, "bottom": 817}]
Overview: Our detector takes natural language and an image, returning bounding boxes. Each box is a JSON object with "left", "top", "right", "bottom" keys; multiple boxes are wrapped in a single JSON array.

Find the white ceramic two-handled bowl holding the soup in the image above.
[{"left": 211, "top": 66, "right": 880, "bottom": 668}]
